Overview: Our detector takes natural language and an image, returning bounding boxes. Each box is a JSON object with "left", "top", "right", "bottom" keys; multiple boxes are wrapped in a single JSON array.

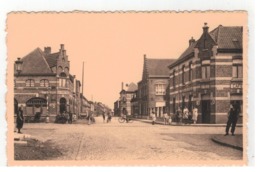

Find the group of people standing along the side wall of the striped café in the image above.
[{"left": 150, "top": 107, "right": 198, "bottom": 125}]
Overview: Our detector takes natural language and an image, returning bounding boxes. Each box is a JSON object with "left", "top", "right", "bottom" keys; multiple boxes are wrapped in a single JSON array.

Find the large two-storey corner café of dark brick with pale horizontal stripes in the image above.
[{"left": 169, "top": 23, "right": 243, "bottom": 123}]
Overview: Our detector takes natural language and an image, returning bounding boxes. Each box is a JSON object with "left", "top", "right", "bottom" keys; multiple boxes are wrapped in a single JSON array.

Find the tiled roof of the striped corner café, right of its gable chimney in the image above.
[{"left": 209, "top": 25, "right": 243, "bottom": 49}]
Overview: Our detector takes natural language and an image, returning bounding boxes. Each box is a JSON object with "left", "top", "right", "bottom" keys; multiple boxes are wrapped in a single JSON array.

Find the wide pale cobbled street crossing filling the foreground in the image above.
[{"left": 23, "top": 117, "right": 243, "bottom": 161}]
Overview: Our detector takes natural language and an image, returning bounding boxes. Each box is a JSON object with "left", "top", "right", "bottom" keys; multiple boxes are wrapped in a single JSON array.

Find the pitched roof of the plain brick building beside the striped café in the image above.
[{"left": 145, "top": 58, "right": 176, "bottom": 76}]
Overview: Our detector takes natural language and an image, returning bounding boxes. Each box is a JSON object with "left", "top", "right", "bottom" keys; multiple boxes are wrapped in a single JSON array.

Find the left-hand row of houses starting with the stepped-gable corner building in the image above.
[{"left": 14, "top": 44, "right": 109, "bottom": 121}]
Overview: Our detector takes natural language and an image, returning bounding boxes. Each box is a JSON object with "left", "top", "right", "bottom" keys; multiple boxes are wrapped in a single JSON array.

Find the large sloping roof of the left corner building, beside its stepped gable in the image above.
[{"left": 21, "top": 48, "right": 53, "bottom": 74}]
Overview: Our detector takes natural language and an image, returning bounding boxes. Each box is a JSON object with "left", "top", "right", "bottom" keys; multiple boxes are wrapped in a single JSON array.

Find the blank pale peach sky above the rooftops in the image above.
[{"left": 6, "top": 12, "right": 247, "bottom": 108}]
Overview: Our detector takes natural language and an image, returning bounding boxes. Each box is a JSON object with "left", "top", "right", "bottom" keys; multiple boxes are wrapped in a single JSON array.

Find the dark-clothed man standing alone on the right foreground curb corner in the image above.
[{"left": 225, "top": 104, "right": 239, "bottom": 136}]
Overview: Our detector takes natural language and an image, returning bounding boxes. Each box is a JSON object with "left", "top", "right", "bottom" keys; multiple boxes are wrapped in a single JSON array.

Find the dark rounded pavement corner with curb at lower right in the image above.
[{"left": 211, "top": 134, "right": 243, "bottom": 151}]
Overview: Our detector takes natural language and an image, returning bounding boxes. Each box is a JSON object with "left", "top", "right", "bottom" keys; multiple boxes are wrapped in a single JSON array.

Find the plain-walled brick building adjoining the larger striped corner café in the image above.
[{"left": 137, "top": 55, "right": 175, "bottom": 117}]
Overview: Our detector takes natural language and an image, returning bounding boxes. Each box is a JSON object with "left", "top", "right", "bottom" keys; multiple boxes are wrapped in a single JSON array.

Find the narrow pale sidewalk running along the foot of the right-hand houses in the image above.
[{"left": 134, "top": 118, "right": 243, "bottom": 127}]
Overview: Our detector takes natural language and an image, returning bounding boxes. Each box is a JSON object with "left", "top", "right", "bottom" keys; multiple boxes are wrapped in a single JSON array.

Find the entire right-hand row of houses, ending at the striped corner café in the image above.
[{"left": 114, "top": 23, "right": 243, "bottom": 123}]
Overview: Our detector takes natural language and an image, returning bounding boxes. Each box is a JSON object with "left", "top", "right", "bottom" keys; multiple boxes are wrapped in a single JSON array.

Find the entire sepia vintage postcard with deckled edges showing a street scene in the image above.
[{"left": 6, "top": 11, "right": 248, "bottom": 166}]
